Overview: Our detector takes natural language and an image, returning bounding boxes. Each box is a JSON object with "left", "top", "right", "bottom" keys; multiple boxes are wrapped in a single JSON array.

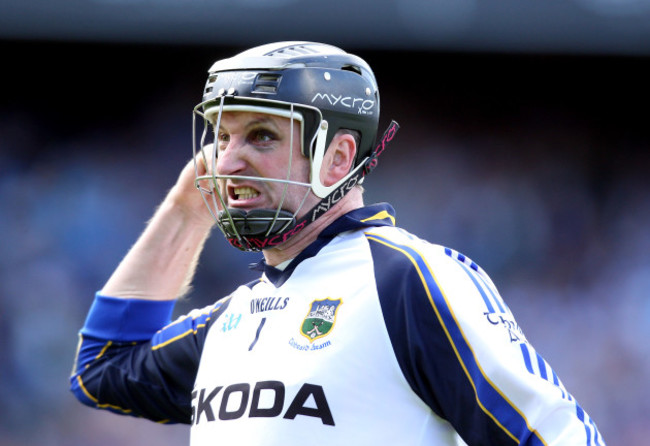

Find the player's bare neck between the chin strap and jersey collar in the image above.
[{"left": 263, "top": 187, "right": 363, "bottom": 266}]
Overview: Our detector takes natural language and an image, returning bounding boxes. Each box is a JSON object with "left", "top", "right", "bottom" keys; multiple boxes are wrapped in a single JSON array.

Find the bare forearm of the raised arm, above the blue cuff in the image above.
[{"left": 101, "top": 181, "right": 212, "bottom": 300}]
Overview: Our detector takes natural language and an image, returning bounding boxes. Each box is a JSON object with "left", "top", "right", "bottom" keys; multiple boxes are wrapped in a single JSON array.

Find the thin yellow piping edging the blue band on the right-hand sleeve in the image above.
[{"left": 366, "top": 232, "right": 547, "bottom": 445}]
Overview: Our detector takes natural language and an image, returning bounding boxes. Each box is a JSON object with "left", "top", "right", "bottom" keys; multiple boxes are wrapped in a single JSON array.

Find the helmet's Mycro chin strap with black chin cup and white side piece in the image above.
[{"left": 218, "top": 121, "right": 399, "bottom": 251}]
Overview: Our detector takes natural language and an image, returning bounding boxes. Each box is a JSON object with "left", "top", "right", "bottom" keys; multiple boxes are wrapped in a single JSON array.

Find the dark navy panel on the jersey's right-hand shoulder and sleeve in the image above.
[{"left": 366, "top": 234, "right": 512, "bottom": 444}]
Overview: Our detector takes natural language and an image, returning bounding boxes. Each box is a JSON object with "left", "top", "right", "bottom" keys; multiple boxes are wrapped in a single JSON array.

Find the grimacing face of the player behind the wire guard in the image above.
[{"left": 211, "top": 112, "right": 315, "bottom": 217}]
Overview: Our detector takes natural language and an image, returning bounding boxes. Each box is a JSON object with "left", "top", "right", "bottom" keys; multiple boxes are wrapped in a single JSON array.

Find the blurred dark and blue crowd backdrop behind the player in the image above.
[{"left": 0, "top": 13, "right": 650, "bottom": 446}]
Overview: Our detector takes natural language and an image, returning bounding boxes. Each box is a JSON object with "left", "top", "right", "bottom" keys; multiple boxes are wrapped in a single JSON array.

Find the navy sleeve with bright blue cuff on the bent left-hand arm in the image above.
[{"left": 70, "top": 294, "right": 228, "bottom": 423}]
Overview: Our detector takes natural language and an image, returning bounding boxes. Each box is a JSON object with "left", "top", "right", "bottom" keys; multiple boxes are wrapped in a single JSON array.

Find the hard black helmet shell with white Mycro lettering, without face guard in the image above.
[{"left": 203, "top": 42, "right": 379, "bottom": 166}]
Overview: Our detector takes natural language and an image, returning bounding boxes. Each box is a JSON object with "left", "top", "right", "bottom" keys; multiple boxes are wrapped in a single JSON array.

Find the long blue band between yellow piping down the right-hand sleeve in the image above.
[{"left": 366, "top": 233, "right": 544, "bottom": 445}]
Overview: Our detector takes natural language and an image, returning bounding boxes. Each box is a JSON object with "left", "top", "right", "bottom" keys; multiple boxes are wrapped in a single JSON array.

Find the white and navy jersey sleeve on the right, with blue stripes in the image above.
[{"left": 368, "top": 236, "right": 604, "bottom": 445}]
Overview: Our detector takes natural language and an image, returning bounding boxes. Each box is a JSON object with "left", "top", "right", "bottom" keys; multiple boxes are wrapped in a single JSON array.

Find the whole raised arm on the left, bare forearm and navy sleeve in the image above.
[{"left": 70, "top": 158, "right": 219, "bottom": 423}]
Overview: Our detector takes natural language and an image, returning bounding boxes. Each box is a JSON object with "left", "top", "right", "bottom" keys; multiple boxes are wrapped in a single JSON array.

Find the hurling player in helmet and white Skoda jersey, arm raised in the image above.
[{"left": 71, "top": 42, "right": 604, "bottom": 445}]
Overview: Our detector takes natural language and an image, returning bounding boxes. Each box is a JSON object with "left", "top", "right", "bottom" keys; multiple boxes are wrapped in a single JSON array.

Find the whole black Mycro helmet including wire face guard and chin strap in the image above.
[{"left": 193, "top": 42, "right": 397, "bottom": 251}]
